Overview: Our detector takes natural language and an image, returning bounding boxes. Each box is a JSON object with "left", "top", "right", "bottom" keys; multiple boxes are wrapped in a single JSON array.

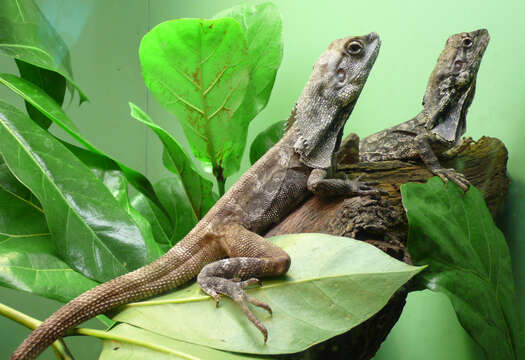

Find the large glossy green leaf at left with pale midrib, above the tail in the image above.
[{"left": 0, "top": 101, "right": 158, "bottom": 281}]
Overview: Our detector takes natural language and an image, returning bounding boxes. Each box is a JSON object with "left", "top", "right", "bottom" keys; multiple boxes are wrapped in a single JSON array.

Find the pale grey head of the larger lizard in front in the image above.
[{"left": 288, "top": 32, "right": 381, "bottom": 168}]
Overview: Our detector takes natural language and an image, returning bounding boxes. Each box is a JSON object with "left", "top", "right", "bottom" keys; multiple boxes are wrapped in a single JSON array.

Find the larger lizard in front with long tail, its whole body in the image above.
[{"left": 11, "top": 33, "right": 380, "bottom": 360}]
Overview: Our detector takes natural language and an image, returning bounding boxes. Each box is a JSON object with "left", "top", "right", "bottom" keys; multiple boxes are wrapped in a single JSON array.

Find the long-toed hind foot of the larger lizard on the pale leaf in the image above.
[{"left": 198, "top": 277, "right": 272, "bottom": 344}]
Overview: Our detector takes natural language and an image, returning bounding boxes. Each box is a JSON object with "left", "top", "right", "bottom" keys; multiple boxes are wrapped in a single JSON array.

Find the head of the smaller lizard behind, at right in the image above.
[{"left": 423, "top": 29, "right": 490, "bottom": 140}]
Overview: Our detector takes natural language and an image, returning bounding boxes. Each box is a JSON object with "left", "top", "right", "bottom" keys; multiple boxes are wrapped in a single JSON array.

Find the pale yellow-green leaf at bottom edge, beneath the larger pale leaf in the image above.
[{"left": 99, "top": 324, "right": 255, "bottom": 360}]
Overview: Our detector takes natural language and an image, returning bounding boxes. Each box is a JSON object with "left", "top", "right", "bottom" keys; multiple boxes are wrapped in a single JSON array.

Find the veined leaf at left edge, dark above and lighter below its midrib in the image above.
[{"left": 0, "top": 164, "right": 96, "bottom": 301}]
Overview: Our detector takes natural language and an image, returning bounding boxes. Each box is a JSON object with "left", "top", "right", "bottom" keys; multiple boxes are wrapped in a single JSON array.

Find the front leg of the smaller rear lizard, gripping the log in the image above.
[{"left": 414, "top": 133, "right": 470, "bottom": 191}]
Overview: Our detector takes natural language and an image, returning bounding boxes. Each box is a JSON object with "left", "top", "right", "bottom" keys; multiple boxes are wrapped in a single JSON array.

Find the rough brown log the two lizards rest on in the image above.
[{"left": 266, "top": 137, "right": 509, "bottom": 360}]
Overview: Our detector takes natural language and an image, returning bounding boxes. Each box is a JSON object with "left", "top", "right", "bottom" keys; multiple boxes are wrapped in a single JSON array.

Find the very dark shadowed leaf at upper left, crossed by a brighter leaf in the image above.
[{"left": 16, "top": 60, "right": 66, "bottom": 129}]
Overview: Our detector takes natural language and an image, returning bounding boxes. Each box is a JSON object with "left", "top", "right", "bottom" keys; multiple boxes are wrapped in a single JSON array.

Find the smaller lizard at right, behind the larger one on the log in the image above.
[{"left": 358, "top": 29, "right": 490, "bottom": 190}]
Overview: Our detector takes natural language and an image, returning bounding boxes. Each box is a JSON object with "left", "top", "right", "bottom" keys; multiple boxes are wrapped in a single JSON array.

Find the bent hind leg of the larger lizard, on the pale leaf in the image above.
[{"left": 197, "top": 223, "right": 291, "bottom": 343}]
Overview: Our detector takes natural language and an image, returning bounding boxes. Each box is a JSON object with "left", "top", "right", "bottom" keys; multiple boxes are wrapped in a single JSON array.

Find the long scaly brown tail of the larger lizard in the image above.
[{"left": 10, "top": 243, "right": 199, "bottom": 360}]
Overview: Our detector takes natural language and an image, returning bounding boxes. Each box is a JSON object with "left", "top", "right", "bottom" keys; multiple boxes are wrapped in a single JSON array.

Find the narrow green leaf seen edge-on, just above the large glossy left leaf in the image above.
[{"left": 0, "top": 74, "right": 161, "bottom": 212}]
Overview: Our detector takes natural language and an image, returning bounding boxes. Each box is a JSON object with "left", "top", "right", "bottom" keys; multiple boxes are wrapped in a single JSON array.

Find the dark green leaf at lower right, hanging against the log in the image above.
[{"left": 401, "top": 177, "right": 525, "bottom": 360}]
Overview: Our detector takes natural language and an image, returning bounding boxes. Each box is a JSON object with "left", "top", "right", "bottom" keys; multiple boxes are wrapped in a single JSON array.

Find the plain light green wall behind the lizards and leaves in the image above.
[{"left": 0, "top": 0, "right": 525, "bottom": 360}]
